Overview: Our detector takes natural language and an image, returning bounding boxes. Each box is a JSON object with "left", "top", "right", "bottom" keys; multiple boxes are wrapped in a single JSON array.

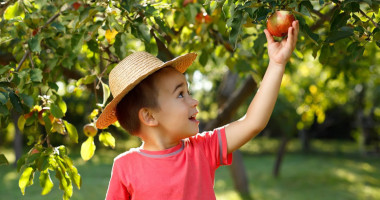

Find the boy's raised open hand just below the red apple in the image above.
[{"left": 264, "top": 20, "right": 299, "bottom": 66}]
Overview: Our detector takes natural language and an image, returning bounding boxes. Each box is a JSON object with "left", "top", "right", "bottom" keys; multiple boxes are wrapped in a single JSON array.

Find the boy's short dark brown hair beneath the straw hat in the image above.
[{"left": 116, "top": 68, "right": 165, "bottom": 135}]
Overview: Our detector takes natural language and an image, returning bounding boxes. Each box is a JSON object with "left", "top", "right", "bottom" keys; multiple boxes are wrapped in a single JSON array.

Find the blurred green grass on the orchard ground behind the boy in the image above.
[{"left": 0, "top": 138, "right": 380, "bottom": 200}]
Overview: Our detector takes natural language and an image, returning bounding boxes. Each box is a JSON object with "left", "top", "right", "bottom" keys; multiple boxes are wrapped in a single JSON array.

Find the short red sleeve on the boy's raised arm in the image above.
[{"left": 190, "top": 127, "right": 232, "bottom": 168}]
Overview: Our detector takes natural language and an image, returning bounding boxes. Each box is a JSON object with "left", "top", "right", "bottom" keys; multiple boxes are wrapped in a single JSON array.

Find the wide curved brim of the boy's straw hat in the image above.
[{"left": 95, "top": 53, "right": 197, "bottom": 129}]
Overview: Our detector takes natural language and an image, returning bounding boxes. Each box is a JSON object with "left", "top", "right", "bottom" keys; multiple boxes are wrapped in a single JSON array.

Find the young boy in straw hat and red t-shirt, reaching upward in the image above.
[{"left": 96, "top": 21, "right": 299, "bottom": 200}]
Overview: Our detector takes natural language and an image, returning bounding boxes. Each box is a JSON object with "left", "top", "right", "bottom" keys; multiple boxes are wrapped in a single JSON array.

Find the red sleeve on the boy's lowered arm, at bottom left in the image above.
[{"left": 106, "top": 159, "right": 130, "bottom": 200}]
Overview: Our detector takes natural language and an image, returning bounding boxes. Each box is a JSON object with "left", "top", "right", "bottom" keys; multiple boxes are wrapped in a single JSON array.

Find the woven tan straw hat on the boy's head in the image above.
[{"left": 96, "top": 52, "right": 197, "bottom": 129}]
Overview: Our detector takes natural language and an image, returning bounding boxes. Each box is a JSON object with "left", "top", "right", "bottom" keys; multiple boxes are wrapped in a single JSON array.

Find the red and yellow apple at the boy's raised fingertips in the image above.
[{"left": 267, "top": 10, "right": 295, "bottom": 37}]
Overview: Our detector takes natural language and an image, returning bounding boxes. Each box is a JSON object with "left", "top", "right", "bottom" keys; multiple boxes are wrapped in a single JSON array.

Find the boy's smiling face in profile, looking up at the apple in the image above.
[{"left": 153, "top": 67, "right": 199, "bottom": 140}]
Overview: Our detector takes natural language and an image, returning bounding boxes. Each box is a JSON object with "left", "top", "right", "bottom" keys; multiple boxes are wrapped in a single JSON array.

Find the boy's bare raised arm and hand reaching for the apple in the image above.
[{"left": 226, "top": 21, "right": 299, "bottom": 153}]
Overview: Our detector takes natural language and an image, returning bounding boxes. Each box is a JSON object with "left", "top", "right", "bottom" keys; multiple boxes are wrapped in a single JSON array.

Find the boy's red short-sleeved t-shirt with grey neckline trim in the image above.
[{"left": 106, "top": 127, "right": 232, "bottom": 200}]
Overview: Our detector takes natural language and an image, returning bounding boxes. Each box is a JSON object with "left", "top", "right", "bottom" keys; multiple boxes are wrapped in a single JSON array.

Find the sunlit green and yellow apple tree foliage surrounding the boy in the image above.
[{"left": 0, "top": 0, "right": 380, "bottom": 199}]
